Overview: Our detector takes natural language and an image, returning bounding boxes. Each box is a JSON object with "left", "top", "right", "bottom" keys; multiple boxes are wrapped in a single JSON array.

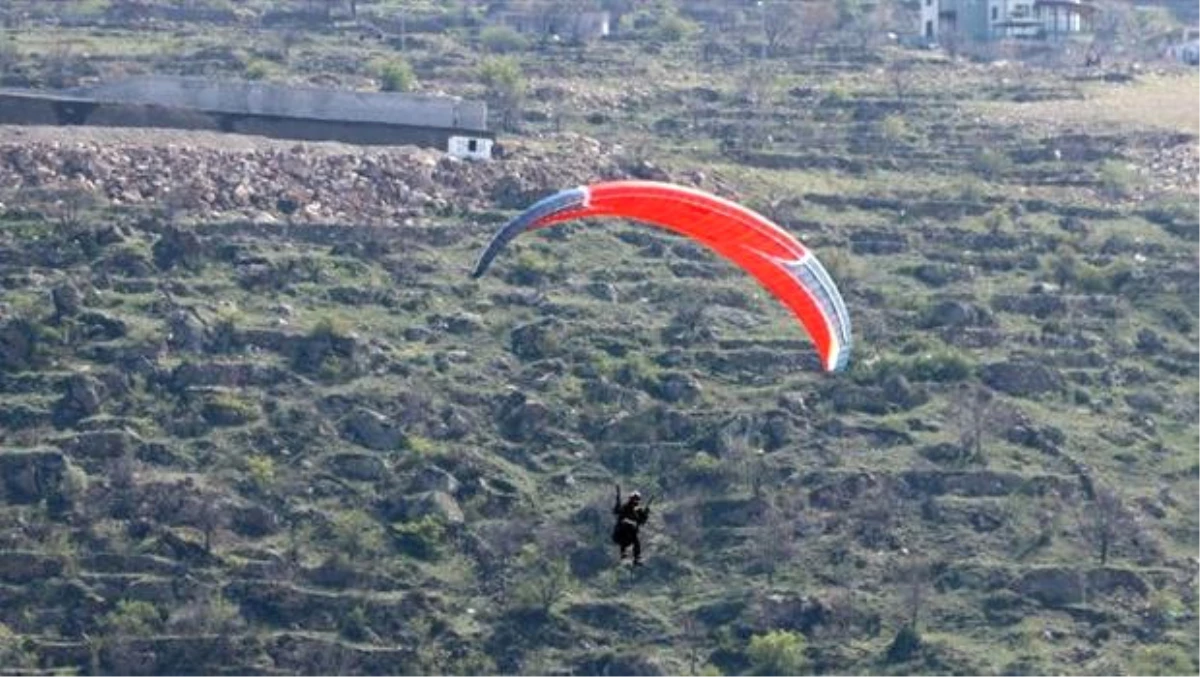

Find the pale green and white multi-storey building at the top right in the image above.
[{"left": 920, "top": 0, "right": 1097, "bottom": 42}]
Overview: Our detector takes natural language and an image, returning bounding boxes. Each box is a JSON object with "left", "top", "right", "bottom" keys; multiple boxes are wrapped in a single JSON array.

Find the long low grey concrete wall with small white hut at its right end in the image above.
[{"left": 0, "top": 76, "right": 494, "bottom": 160}]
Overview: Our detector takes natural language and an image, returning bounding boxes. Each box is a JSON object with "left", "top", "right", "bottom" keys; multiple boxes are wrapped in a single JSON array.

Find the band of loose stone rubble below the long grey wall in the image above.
[{"left": 0, "top": 127, "right": 720, "bottom": 224}]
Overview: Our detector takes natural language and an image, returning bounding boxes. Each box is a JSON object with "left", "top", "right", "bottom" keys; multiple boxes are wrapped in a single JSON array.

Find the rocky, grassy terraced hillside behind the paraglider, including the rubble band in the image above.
[{"left": 0, "top": 6, "right": 1200, "bottom": 676}]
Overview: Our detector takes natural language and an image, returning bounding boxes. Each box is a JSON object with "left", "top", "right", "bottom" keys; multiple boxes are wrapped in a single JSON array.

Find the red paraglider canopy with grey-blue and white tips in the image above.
[{"left": 472, "top": 181, "right": 852, "bottom": 371}]
